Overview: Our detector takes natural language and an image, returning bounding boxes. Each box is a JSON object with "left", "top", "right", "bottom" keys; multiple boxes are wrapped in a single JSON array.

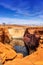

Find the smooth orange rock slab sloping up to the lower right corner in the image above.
[{"left": 4, "top": 44, "right": 43, "bottom": 65}]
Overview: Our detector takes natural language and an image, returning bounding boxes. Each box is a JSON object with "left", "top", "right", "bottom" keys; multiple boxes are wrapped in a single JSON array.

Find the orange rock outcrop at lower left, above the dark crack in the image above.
[{"left": 0, "top": 43, "right": 17, "bottom": 63}]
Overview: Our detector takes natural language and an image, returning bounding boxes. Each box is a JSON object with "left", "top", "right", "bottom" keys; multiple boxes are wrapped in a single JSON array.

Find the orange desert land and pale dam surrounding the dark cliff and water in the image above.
[{"left": 0, "top": 25, "right": 43, "bottom": 65}]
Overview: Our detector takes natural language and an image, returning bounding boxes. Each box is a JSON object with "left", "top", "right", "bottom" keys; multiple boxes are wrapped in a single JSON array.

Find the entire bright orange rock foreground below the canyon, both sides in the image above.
[{"left": 0, "top": 43, "right": 43, "bottom": 65}]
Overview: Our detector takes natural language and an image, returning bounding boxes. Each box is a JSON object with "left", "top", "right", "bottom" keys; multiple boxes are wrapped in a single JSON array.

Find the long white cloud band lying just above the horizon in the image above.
[{"left": 0, "top": 18, "right": 43, "bottom": 25}]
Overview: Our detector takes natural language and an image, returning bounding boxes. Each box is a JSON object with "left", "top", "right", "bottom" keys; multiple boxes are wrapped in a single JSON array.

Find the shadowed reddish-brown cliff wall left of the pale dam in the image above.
[{"left": 0, "top": 28, "right": 10, "bottom": 43}]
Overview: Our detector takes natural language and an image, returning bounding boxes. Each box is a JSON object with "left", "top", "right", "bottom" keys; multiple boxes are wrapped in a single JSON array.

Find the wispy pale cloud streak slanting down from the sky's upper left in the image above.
[{"left": 0, "top": 3, "right": 30, "bottom": 16}]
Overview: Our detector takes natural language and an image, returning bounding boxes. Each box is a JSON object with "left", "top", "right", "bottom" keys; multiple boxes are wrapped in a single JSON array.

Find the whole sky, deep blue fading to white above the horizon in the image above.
[{"left": 0, "top": 0, "right": 43, "bottom": 25}]
